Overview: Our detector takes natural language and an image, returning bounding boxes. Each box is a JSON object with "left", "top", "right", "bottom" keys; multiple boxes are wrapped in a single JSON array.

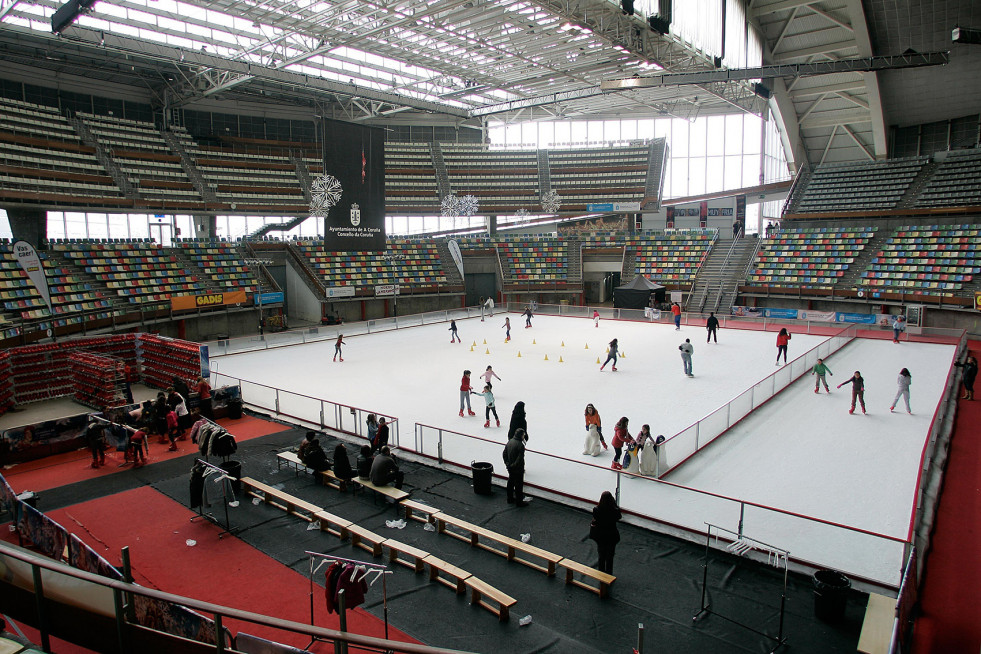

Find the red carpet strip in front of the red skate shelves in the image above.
[{"left": 3, "top": 416, "right": 288, "bottom": 493}]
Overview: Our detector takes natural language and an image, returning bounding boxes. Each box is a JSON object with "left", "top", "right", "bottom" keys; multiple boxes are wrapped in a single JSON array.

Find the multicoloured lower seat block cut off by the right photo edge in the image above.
[{"left": 862, "top": 225, "right": 981, "bottom": 295}]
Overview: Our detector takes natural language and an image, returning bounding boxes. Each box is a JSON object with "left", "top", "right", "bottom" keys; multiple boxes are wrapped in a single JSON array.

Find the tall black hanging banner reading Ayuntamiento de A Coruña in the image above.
[{"left": 323, "top": 119, "right": 385, "bottom": 252}]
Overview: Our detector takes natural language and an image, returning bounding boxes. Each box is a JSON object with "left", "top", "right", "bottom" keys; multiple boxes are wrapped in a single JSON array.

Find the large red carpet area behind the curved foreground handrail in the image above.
[{"left": 47, "top": 487, "right": 418, "bottom": 652}]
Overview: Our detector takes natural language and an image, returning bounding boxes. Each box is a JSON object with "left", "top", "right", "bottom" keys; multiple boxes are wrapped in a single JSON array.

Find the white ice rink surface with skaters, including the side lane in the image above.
[{"left": 217, "top": 314, "right": 955, "bottom": 583}]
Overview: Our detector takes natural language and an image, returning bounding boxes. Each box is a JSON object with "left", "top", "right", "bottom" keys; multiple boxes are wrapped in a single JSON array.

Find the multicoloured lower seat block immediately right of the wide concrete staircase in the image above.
[{"left": 748, "top": 227, "right": 877, "bottom": 288}]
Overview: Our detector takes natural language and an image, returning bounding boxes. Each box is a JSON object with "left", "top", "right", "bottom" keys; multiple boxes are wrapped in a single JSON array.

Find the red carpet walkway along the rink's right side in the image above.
[{"left": 913, "top": 341, "right": 981, "bottom": 654}]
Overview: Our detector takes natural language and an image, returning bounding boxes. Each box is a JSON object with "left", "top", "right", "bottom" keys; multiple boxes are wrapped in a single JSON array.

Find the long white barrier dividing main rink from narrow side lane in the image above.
[{"left": 657, "top": 325, "right": 858, "bottom": 478}]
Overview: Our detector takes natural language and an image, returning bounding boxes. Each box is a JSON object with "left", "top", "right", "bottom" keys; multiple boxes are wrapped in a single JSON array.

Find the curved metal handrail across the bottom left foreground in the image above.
[{"left": 0, "top": 541, "right": 466, "bottom": 654}]
